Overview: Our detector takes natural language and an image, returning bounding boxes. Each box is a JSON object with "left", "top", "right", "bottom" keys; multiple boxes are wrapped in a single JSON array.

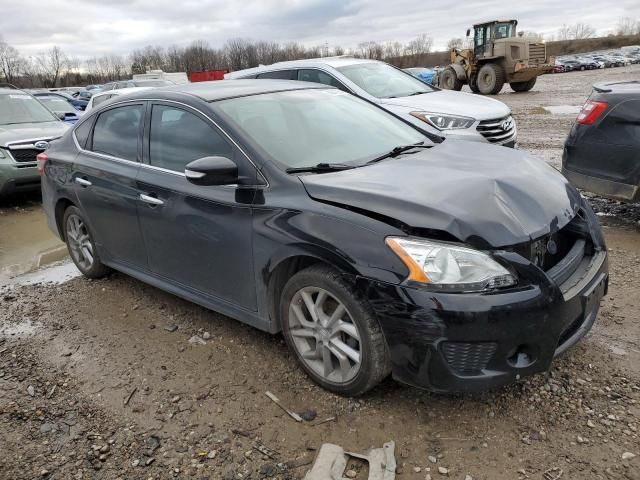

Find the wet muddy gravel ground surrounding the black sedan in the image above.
[{"left": 0, "top": 66, "right": 640, "bottom": 480}]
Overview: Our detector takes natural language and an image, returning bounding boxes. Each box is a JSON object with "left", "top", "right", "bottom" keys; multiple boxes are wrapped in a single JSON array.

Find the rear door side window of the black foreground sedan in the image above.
[{"left": 91, "top": 105, "right": 144, "bottom": 162}]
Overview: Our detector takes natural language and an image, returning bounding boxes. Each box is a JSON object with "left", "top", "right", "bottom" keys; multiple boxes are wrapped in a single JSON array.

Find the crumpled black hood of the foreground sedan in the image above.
[{"left": 300, "top": 141, "right": 582, "bottom": 248}]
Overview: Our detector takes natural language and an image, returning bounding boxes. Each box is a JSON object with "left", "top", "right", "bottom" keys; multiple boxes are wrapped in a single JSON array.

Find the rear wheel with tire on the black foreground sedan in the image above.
[{"left": 62, "top": 206, "right": 109, "bottom": 278}]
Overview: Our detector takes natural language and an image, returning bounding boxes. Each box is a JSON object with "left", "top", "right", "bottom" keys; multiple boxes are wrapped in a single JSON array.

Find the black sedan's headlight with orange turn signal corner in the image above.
[{"left": 386, "top": 237, "right": 516, "bottom": 292}]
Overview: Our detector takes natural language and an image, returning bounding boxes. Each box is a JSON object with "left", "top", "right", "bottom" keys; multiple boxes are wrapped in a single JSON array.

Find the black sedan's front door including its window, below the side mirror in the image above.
[{"left": 138, "top": 102, "right": 257, "bottom": 311}]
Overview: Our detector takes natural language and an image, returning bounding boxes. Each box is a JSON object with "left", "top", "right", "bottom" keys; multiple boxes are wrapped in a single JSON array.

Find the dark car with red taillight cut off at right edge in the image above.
[{"left": 562, "top": 80, "right": 640, "bottom": 202}]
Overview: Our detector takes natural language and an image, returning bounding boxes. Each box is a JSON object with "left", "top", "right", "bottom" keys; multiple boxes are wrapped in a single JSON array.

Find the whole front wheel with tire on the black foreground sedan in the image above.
[{"left": 280, "top": 265, "right": 391, "bottom": 396}]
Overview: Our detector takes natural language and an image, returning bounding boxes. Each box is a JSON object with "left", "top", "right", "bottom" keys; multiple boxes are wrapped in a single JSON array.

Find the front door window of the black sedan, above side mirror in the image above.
[{"left": 149, "top": 105, "right": 233, "bottom": 172}]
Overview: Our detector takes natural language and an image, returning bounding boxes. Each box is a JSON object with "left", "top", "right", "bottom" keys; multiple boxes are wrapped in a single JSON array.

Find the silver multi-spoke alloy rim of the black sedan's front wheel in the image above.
[{"left": 289, "top": 287, "right": 362, "bottom": 384}]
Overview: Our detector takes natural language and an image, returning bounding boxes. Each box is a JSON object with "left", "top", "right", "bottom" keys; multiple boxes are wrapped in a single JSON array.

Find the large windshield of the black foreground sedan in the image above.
[{"left": 213, "top": 89, "right": 431, "bottom": 169}]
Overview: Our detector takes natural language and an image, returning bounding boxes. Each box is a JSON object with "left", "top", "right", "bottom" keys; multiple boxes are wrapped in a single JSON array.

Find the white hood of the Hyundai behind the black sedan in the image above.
[{"left": 380, "top": 90, "right": 511, "bottom": 120}]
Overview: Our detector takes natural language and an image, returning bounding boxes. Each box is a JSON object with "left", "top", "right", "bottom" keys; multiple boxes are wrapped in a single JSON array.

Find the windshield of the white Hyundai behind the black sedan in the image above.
[{"left": 338, "top": 63, "right": 435, "bottom": 98}]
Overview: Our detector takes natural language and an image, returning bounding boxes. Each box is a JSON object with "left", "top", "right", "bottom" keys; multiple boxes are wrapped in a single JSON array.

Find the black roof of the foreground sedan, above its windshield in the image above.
[{"left": 122, "top": 80, "right": 334, "bottom": 102}]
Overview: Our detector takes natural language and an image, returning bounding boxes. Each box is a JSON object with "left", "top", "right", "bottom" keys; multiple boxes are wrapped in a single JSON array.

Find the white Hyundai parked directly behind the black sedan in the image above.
[{"left": 225, "top": 57, "right": 517, "bottom": 147}]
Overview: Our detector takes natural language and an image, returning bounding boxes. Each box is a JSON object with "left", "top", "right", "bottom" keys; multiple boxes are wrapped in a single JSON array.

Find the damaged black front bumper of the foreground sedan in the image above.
[{"left": 362, "top": 250, "right": 609, "bottom": 392}]
